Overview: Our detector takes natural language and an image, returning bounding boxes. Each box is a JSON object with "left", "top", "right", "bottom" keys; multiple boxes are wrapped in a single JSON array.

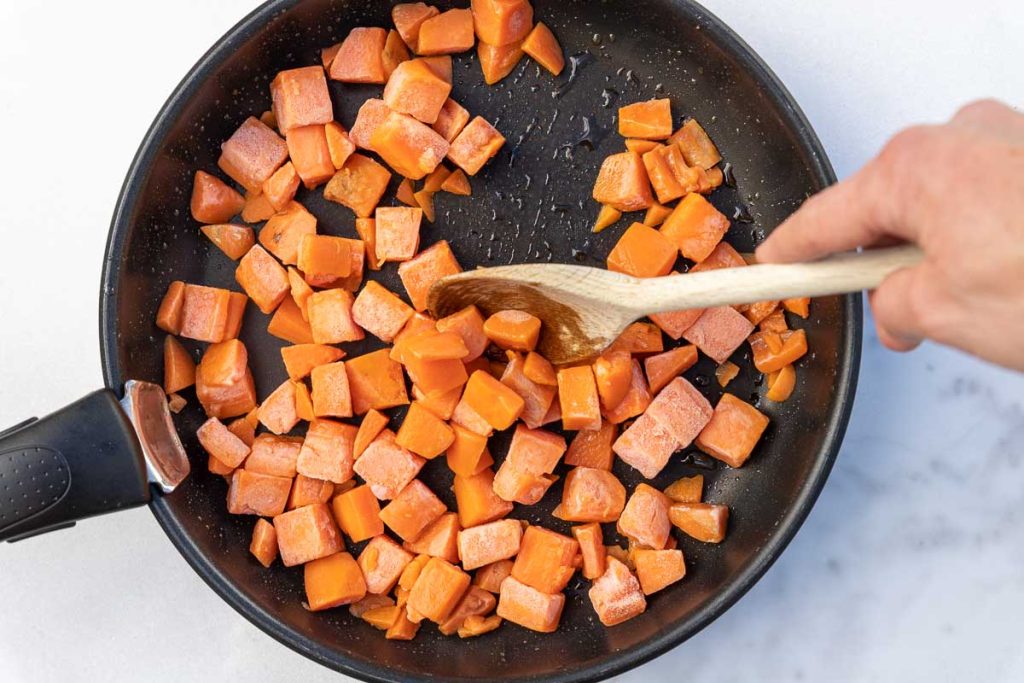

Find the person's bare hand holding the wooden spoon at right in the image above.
[{"left": 757, "top": 100, "right": 1024, "bottom": 370}]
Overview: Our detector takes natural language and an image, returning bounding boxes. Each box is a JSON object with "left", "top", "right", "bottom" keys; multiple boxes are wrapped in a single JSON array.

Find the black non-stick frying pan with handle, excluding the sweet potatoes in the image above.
[{"left": 0, "top": 0, "right": 862, "bottom": 681}]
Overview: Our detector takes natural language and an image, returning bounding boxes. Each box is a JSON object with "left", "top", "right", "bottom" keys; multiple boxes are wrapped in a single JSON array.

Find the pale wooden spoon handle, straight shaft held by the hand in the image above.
[{"left": 632, "top": 245, "right": 924, "bottom": 313}]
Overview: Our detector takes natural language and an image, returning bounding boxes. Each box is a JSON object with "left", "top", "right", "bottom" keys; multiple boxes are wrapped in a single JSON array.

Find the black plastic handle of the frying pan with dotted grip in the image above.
[{"left": 0, "top": 389, "right": 150, "bottom": 541}]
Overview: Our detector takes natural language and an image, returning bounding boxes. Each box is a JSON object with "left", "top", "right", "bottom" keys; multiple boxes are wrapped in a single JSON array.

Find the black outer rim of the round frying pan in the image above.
[{"left": 99, "top": 0, "right": 863, "bottom": 681}]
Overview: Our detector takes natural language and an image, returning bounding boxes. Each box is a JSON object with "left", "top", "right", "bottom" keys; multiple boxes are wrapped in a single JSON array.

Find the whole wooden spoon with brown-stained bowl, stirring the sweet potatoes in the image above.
[{"left": 428, "top": 246, "right": 924, "bottom": 365}]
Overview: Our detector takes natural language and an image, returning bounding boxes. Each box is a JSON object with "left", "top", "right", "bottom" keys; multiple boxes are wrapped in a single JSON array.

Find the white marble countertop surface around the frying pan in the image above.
[{"left": 0, "top": 0, "right": 1024, "bottom": 683}]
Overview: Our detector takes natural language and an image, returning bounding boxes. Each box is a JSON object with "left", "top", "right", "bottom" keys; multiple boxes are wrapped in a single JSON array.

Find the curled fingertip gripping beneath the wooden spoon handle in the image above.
[{"left": 868, "top": 266, "right": 927, "bottom": 351}]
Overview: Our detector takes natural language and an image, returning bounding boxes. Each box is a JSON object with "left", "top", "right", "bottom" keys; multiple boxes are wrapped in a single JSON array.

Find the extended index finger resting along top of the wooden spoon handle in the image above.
[{"left": 757, "top": 127, "right": 935, "bottom": 263}]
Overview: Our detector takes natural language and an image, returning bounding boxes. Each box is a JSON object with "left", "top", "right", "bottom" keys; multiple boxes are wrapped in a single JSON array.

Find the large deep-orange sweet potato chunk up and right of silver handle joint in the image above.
[{"left": 196, "top": 339, "right": 256, "bottom": 419}]
